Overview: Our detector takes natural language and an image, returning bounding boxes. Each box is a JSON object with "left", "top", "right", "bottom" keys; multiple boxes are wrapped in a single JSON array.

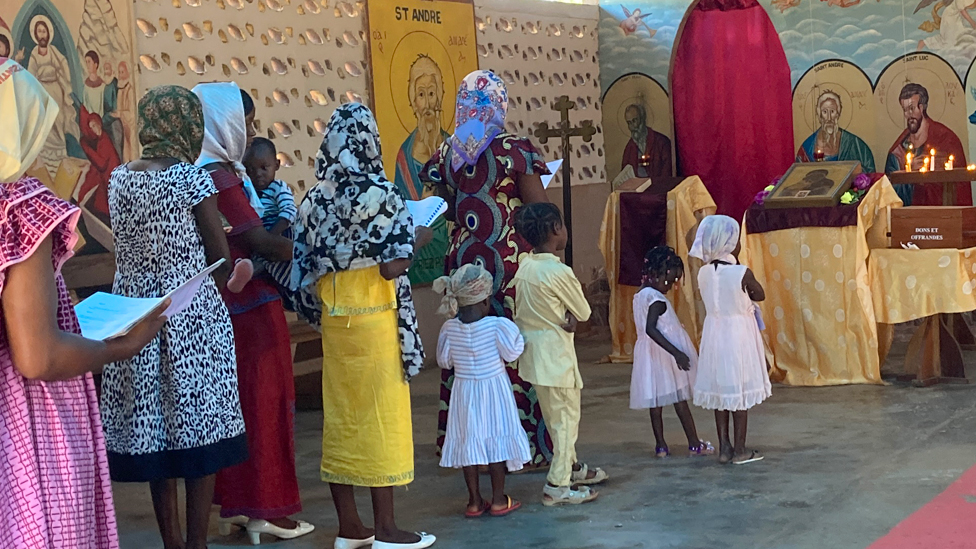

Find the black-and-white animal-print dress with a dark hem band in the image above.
[{"left": 101, "top": 163, "right": 247, "bottom": 482}]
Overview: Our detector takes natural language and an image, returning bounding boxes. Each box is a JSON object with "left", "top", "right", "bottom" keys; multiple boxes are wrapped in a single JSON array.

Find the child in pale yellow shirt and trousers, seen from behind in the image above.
[{"left": 515, "top": 203, "right": 609, "bottom": 506}]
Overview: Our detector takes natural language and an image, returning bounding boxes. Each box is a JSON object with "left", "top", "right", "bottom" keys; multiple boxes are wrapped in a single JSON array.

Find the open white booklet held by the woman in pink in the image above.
[{"left": 75, "top": 259, "right": 224, "bottom": 341}]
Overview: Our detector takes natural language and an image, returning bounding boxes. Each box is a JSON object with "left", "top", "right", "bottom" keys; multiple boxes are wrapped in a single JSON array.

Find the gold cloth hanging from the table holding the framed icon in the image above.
[{"left": 739, "top": 177, "right": 904, "bottom": 386}]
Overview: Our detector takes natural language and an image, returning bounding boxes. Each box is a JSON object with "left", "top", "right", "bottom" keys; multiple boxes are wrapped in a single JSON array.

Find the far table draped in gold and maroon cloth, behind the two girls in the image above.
[{"left": 599, "top": 176, "right": 715, "bottom": 362}]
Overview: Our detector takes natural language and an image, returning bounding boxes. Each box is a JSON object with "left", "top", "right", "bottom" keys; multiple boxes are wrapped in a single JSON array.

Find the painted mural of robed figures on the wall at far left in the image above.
[{"left": 0, "top": 0, "right": 136, "bottom": 254}]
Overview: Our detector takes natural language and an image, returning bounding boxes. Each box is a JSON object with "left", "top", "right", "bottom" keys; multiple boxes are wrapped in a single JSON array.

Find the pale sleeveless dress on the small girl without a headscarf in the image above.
[{"left": 630, "top": 288, "right": 698, "bottom": 410}]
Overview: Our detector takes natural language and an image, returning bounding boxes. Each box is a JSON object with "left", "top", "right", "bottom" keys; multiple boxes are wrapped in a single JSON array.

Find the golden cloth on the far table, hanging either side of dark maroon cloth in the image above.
[{"left": 599, "top": 176, "right": 715, "bottom": 362}]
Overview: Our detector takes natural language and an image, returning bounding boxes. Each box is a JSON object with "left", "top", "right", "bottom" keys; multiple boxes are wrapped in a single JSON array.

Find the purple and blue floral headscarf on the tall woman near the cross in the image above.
[{"left": 449, "top": 71, "right": 508, "bottom": 170}]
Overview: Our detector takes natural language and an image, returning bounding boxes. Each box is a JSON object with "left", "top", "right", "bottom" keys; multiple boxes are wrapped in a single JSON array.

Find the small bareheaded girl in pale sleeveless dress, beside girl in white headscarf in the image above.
[{"left": 630, "top": 246, "right": 715, "bottom": 458}]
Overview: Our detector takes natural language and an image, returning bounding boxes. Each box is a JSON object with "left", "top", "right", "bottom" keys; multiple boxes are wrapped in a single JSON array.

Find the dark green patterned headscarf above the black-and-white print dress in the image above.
[{"left": 139, "top": 86, "right": 203, "bottom": 164}]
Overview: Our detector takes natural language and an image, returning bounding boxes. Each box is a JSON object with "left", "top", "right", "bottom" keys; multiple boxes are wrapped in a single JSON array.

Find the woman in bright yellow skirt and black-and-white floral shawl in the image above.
[{"left": 292, "top": 103, "right": 435, "bottom": 549}]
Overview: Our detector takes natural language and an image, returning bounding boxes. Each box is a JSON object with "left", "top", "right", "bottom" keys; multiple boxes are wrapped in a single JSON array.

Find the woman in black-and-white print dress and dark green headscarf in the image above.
[{"left": 101, "top": 86, "right": 247, "bottom": 547}]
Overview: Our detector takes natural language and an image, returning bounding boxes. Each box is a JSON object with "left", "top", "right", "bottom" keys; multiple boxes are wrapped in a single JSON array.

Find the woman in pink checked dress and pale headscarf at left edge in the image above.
[{"left": 0, "top": 58, "right": 166, "bottom": 549}]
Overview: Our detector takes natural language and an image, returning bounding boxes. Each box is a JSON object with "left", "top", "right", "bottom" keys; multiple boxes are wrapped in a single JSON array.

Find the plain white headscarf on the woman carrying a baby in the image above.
[{"left": 193, "top": 82, "right": 264, "bottom": 217}]
